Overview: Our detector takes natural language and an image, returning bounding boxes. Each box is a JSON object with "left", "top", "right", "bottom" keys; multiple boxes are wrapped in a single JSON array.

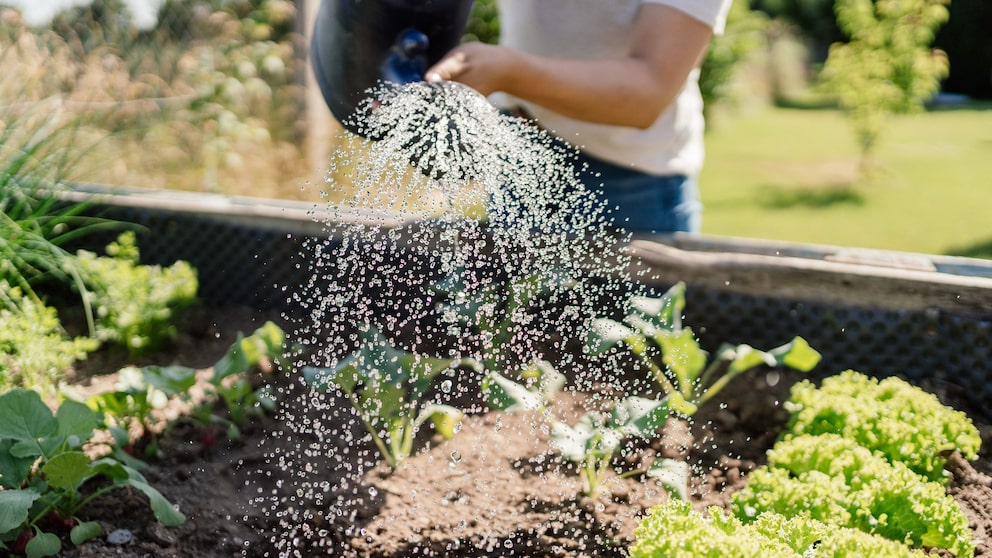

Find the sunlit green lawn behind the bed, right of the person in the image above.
[{"left": 700, "top": 104, "right": 992, "bottom": 257}]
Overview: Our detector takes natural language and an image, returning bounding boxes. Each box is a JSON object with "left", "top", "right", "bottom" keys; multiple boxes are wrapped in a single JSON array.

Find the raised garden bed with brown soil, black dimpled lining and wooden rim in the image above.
[{"left": 19, "top": 189, "right": 992, "bottom": 557}]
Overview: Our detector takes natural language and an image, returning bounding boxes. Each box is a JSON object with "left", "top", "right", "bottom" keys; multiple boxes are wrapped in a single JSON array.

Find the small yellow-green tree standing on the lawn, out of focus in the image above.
[{"left": 820, "top": 0, "right": 950, "bottom": 172}]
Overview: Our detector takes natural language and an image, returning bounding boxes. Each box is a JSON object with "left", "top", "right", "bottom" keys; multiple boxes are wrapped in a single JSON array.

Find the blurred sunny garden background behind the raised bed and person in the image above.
[{"left": 0, "top": 0, "right": 992, "bottom": 257}]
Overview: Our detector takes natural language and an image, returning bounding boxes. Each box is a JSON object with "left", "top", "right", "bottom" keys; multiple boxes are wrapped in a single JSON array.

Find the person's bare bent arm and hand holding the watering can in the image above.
[{"left": 426, "top": 3, "right": 713, "bottom": 128}]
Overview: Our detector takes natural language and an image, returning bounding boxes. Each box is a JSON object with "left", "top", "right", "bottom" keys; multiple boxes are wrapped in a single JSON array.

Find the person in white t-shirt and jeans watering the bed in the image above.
[{"left": 425, "top": 0, "right": 731, "bottom": 233}]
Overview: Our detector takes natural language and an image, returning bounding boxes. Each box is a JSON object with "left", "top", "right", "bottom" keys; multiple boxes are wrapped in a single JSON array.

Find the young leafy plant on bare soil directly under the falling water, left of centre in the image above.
[{"left": 303, "top": 328, "right": 478, "bottom": 469}]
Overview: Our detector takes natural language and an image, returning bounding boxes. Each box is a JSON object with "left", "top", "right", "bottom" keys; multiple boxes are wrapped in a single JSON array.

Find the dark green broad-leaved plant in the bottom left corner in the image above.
[{"left": 0, "top": 389, "right": 186, "bottom": 558}]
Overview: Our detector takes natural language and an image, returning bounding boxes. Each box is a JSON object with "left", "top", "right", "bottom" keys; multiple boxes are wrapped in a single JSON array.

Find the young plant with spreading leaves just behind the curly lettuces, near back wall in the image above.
[{"left": 586, "top": 282, "right": 820, "bottom": 415}]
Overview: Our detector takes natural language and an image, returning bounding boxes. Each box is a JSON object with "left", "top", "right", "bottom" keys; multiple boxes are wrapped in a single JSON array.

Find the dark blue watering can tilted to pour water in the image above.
[{"left": 311, "top": 0, "right": 472, "bottom": 133}]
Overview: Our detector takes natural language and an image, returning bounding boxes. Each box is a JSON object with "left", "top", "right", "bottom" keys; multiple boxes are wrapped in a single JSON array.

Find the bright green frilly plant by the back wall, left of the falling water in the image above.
[{"left": 75, "top": 231, "right": 198, "bottom": 355}]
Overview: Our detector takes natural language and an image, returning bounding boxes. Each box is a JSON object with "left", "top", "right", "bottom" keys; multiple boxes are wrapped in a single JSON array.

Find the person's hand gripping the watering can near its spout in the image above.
[{"left": 424, "top": 43, "right": 524, "bottom": 96}]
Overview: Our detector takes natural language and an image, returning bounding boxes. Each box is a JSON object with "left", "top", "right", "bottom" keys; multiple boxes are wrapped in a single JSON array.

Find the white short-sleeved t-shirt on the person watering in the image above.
[{"left": 492, "top": 0, "right": 731, "bottom": 176}]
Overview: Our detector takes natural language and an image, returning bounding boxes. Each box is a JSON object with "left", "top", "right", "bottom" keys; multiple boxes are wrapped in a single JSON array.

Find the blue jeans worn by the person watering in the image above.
[{"left": 575, "top": 153, "right": 703, "bottom": 233}]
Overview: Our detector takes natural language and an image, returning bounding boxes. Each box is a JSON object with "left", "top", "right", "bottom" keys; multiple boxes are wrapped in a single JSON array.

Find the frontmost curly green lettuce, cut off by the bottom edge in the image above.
[{"left": 629, "top": 500, "right": 923, "bottom": 558}]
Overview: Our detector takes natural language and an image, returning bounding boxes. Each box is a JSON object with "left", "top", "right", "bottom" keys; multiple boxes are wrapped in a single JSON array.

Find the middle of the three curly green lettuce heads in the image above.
[{"left": 732, "top": 434, "right": 975, "bottom": 557}]
